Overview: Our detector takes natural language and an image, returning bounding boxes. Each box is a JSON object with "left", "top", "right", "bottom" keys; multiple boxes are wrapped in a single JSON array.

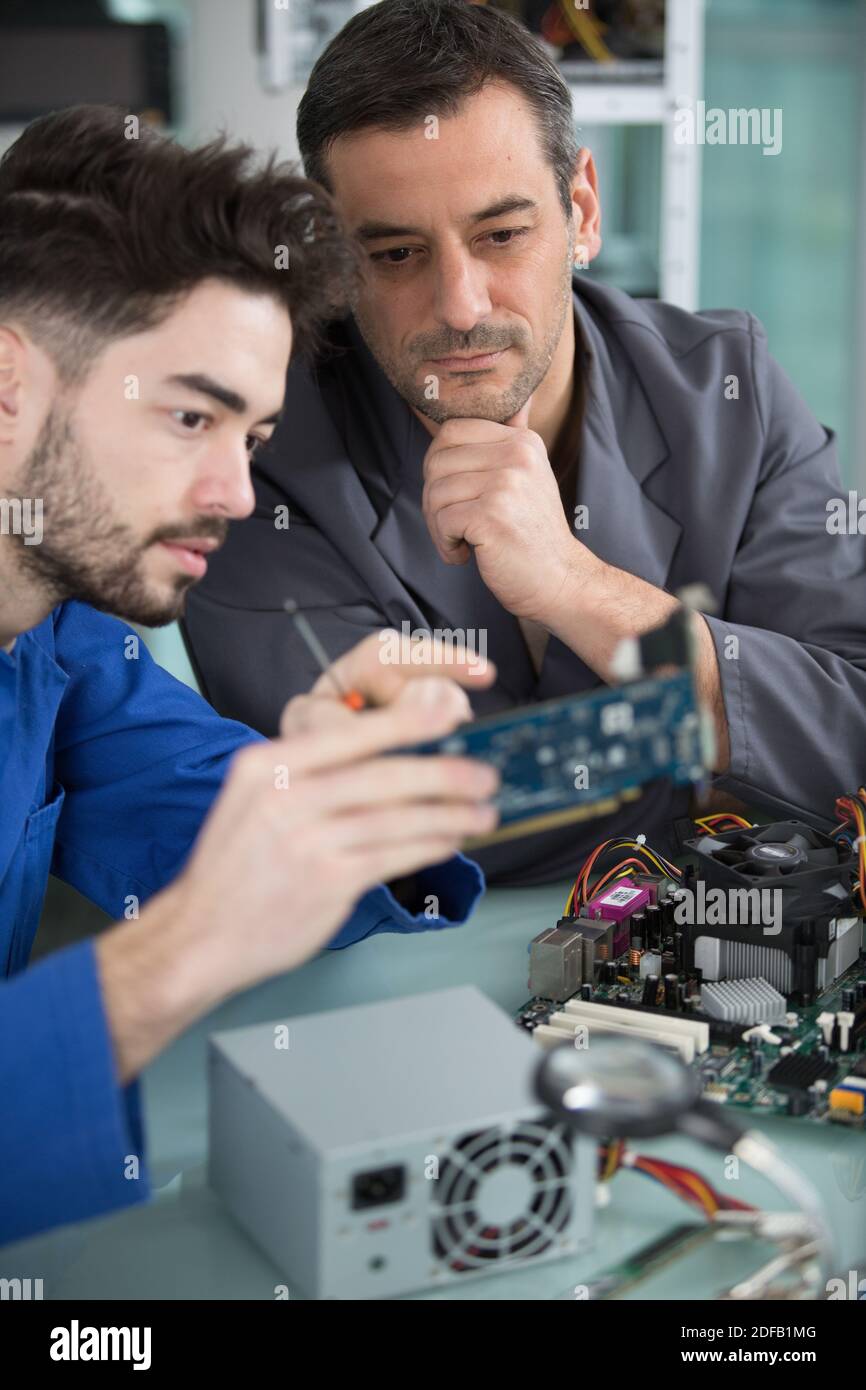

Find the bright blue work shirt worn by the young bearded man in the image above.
[{"left": 0, "top": 603, "right": 482, "bottom": 1241}]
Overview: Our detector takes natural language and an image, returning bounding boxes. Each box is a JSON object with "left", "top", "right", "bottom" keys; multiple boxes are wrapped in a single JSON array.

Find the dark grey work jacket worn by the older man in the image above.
[{"left": 186, "top": 275, "right": 866, "bottom": 883}]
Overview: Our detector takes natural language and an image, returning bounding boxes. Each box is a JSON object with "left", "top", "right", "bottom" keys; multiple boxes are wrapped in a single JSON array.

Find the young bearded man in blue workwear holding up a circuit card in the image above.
[{"left": 0, "top": 107, "right": 495, "bottom": 1240}]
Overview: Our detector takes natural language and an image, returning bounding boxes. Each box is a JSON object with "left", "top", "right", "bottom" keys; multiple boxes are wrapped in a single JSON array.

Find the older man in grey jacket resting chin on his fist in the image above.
[{"left": 179, "top": 0, "right": 866, "bottom": 883}]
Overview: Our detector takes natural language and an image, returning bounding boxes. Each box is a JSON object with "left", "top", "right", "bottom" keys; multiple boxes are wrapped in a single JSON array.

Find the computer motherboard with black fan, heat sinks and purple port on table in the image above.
[{"left": 517, "top": 817, "right": 866, "bottom": 1130}]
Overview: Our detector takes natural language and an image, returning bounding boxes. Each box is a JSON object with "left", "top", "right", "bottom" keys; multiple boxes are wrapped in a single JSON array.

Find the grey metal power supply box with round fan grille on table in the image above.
[{"left": 210, "top": 986, "right": 596, "bottom": 1300}]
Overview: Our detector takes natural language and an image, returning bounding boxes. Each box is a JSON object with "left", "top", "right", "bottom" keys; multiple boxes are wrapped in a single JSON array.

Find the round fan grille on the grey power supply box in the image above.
[{"left": 431, "top": 1120, "right": 574, "bottom": 1273}]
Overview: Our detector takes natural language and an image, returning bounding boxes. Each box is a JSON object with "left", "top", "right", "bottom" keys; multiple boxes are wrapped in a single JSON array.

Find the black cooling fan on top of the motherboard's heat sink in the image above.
[{"left": 685, "top": 820, "right": 856, "bottom": 906}]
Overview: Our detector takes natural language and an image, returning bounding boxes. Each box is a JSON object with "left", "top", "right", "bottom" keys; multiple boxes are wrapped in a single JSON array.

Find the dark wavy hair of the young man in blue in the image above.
[{"left": 0, "top": 106, "right": 359, "bottom": 381}]
